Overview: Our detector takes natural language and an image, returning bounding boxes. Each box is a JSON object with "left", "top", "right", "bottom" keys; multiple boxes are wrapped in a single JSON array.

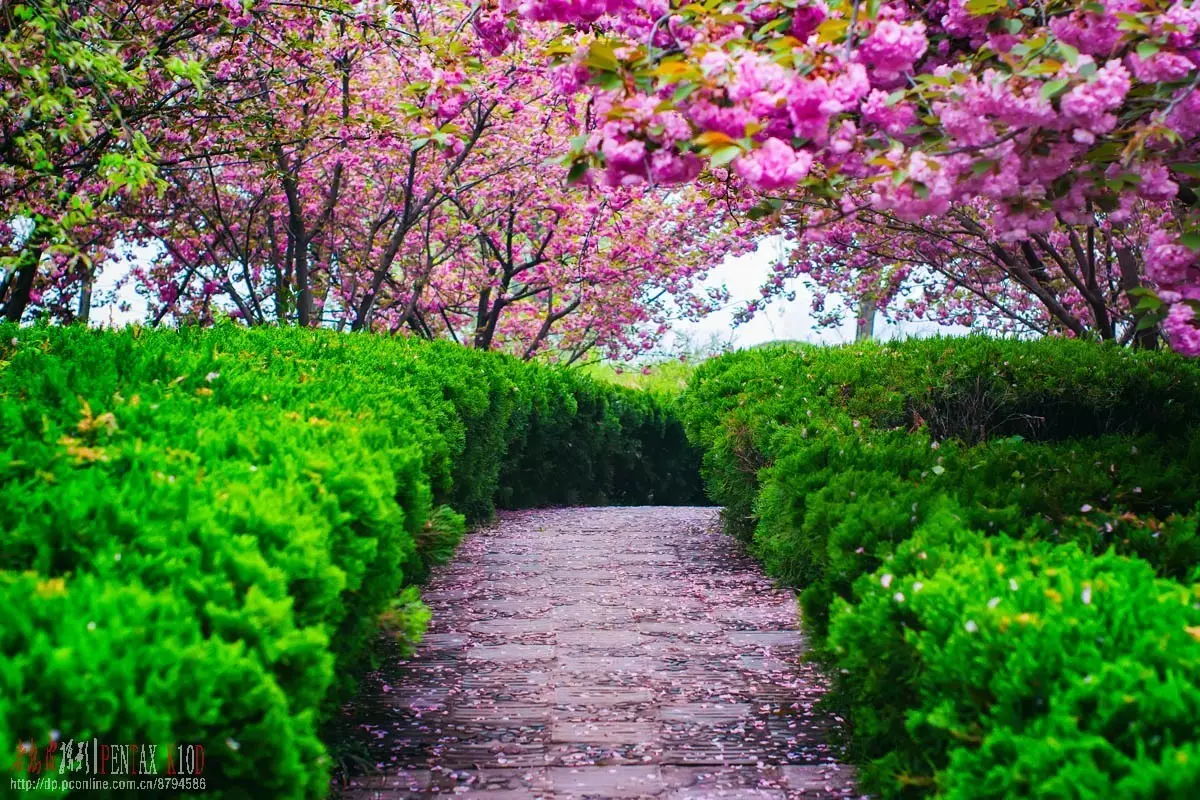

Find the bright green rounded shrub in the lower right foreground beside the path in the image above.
[{"left": 829, "top": 504, "right": 1200, "bottom": 800}]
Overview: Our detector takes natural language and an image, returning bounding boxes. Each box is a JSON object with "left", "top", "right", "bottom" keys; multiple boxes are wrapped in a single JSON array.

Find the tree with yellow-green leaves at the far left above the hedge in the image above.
[{"left": 0, "top": 0, "right": 230, "bottom": 320}]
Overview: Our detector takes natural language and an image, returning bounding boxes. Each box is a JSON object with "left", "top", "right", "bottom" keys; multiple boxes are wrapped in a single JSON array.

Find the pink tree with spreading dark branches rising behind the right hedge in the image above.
[{"left": 738, "top": 195, "right": 1162, "bottom": 347}]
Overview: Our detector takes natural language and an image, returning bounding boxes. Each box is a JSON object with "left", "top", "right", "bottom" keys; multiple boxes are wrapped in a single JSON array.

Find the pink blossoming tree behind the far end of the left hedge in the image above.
[{"left": 422, "top": 176, "right": 752, "bottom": 361}]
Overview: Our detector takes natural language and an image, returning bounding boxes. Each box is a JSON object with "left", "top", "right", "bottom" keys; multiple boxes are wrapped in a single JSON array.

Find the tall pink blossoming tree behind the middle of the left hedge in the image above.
[{"left": 113, "top": 4, "right": 506, "bottom": 330}]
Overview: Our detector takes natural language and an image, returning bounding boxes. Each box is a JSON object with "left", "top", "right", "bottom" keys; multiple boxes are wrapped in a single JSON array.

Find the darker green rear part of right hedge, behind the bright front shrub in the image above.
[{"left": 682, "top": 337, "right": 1200, "bottom": 614}]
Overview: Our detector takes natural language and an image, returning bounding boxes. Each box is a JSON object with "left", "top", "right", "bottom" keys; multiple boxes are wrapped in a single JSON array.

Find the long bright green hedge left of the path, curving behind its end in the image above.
[{"left": 0, "top": 326, "right": 698, "bottom": 798}]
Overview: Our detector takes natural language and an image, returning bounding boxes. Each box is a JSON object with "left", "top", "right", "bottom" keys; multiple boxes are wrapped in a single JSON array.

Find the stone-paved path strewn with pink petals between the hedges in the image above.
[{"left": 342, "top": 507, "right": 857, "bottom": 800}]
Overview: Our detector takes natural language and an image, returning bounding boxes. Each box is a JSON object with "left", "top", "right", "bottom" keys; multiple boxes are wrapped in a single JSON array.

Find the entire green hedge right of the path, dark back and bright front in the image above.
[{"left": 683, "top": 337, "right": 1200, "bottom": 798}]
